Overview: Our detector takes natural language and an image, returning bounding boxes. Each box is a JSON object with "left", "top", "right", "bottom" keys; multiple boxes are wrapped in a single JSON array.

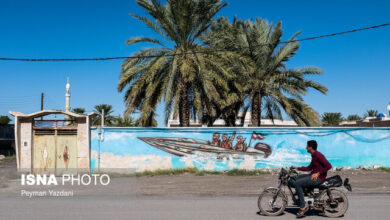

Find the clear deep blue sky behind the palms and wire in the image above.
[{"left": 0, "top": 0, "right": 390, "bottom": 126}]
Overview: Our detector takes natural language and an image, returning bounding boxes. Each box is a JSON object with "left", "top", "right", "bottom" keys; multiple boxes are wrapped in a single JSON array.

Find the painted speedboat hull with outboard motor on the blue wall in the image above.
[{"left": 138, "top": 137, "right": 272, "bottom": 158}]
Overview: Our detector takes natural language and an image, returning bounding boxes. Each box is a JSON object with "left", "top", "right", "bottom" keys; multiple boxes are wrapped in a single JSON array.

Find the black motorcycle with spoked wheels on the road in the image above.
[{"left": 258, "top": 168, "right": 352, "bottom": 217}]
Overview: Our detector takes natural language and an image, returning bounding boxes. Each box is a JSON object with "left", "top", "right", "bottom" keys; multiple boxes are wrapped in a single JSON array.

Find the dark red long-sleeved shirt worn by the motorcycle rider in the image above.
[{"left": 297, "top": 151, "right": 332, "bottom": 182}]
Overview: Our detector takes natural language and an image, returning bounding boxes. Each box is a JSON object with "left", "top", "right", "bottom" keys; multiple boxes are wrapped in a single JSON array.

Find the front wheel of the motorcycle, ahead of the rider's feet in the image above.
[{"left": 257, "top": 189, "right": 287, "bottom": 216}]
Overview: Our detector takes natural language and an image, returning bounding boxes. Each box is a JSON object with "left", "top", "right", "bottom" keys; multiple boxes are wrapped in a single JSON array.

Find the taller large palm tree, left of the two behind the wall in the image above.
[{"left": 118, "top": 0, "right": 230, "bottom": 126}]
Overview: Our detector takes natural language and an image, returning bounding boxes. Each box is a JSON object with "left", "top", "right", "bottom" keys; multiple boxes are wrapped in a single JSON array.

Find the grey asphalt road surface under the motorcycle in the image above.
[{"left": 0, "top": 194, "right": 390, "bottom": 220}]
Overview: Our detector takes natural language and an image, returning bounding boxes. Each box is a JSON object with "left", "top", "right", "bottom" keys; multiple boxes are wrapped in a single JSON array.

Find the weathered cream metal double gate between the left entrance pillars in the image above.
[{"left": 32, "top": 120, "right": 77, "bottom": 175}]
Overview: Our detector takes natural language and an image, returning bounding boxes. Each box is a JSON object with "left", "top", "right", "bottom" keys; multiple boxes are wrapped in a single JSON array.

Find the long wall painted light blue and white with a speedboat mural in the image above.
[{"left": 91, "top": 128, "right": 390, "bottom": 172}]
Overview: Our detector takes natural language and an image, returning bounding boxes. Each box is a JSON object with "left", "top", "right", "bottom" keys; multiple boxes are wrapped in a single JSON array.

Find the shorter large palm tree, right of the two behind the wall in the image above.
[{"left": 206, "top": 18, "right": 327, "bottom": 126}]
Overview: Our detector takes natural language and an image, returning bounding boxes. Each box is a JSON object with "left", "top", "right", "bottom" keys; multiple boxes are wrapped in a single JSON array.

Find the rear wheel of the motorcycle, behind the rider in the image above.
[{"left": 320, "top": 189, "right": 348, "bottom": 218}]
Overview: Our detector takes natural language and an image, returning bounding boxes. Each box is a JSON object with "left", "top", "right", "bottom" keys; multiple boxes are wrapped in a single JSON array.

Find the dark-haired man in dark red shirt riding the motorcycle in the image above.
[{"left": 291, "top": 140, "right": 332, "bottom": 217}]
